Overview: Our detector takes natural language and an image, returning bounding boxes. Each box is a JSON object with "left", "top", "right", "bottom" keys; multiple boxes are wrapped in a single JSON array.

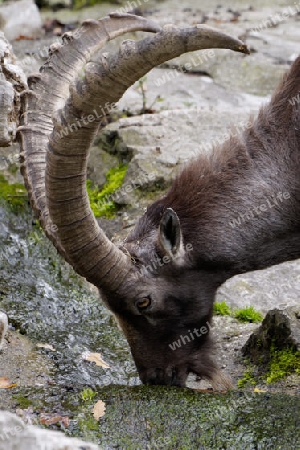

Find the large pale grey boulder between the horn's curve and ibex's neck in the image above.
[{"left": 88, "top": 87, "right": 263, "bottom": 205}]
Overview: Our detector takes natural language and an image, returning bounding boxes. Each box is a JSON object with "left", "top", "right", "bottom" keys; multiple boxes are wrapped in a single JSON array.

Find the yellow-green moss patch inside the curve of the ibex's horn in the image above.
[{"left": 87, "top": 164, "right": 128, "bottom": 219}]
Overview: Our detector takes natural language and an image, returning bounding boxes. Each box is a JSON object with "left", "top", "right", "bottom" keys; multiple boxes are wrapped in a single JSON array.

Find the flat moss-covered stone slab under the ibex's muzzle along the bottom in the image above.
[{"left": 12, "top": 385, "right": 300, "bottom": 450}]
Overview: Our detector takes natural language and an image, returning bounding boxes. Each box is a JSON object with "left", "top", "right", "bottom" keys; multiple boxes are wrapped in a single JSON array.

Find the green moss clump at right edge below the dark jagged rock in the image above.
[{"left": 267, "top": 345, "right": 300, "bottom": 383}]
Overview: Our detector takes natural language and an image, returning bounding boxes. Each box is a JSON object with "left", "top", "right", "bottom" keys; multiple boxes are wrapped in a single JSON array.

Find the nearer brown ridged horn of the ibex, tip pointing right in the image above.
[{"left": 20, "top": 15, "right": 247, "bottom": 289}]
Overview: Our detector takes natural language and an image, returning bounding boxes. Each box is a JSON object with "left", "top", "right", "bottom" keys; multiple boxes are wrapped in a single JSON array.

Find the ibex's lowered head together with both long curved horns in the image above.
[{"left": 18, "top": 14, "right": 247, "bottom": 386}]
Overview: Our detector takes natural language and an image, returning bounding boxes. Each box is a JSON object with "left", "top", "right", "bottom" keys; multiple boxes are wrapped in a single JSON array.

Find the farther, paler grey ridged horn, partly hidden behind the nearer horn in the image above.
[{"left": 17, "top": 13, "right": 160, "bottom": 268}]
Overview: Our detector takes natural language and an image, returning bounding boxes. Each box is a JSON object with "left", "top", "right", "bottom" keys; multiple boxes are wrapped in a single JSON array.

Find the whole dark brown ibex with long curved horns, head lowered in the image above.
[{"left": 18, "top": 14, "right": 300, "bottom": 386}]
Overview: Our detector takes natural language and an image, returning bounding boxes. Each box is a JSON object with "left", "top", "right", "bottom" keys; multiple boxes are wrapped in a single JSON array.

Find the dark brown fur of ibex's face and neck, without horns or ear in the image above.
[{"left": 100, "top": 58, "right": 300, "bottom": 385}]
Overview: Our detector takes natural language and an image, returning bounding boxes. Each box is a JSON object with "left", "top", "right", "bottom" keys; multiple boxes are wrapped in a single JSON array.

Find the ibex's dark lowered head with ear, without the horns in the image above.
[{"left": 101, "top": 204, "right": 225, "bottom": 386}]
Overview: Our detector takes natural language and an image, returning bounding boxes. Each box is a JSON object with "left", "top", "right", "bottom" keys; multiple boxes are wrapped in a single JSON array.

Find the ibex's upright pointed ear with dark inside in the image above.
[{"left": 158, "top": 208, "right": 183, "bottom": 259}]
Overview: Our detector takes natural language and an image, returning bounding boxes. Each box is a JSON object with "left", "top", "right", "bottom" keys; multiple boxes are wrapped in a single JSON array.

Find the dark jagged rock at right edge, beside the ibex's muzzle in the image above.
[{"left": 242, "top": 306, "right": 300, "bottom": 364}]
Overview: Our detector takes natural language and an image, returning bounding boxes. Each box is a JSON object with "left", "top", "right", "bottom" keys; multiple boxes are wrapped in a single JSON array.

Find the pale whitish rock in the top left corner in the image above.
[{"left": 0, "top": 0, "right": 43, "bottom": 41}]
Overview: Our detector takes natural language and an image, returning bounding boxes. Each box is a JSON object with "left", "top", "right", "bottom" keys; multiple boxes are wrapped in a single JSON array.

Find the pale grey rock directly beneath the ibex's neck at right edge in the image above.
[{"left": 216, "top": 260, "right": 300, "bottom": 314}]
